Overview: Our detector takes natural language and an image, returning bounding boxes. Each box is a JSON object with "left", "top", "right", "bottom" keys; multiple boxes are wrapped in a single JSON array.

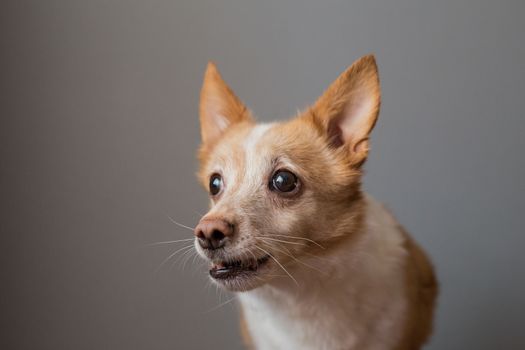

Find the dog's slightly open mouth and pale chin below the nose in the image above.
[{"left": 205, "top": 255, "right": 271, "bottom": 292}]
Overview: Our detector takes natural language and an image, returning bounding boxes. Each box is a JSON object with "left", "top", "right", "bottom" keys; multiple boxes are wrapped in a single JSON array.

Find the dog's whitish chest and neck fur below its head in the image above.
[{"left": 239, "top": 197, "right": 407, "bottom": 350}]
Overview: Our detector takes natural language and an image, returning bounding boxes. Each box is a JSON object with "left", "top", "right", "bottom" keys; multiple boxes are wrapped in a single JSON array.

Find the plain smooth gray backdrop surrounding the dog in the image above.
[{"left": 0, "top": 0, "right": 525, "bottom": 349}]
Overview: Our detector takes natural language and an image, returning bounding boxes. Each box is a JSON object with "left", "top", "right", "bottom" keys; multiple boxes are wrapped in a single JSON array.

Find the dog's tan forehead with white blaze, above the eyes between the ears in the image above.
[{"left": 205, "top": 119, "right": 334, "bottom": 183}]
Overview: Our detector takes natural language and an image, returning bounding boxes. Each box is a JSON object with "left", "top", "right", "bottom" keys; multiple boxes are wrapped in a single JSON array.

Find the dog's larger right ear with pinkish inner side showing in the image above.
[{"left": 311, "top": 55, "right": 381, "bottom": 164}]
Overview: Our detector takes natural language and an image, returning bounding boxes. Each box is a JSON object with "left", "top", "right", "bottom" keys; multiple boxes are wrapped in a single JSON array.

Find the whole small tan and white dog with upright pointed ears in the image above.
[{"left": 195, "top": 56, "right": 437, "bottom": 350}]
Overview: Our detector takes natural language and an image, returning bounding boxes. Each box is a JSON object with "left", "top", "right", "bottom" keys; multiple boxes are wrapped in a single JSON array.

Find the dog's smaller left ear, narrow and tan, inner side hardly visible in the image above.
[{"left": 199, "top": 62, "right": 251, "bottom": 144}]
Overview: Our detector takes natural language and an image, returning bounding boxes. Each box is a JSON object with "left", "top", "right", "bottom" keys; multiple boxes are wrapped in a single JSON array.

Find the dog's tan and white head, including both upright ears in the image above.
[{"left": 195, "top": 56, "right": 379, "bottom": 291}]
